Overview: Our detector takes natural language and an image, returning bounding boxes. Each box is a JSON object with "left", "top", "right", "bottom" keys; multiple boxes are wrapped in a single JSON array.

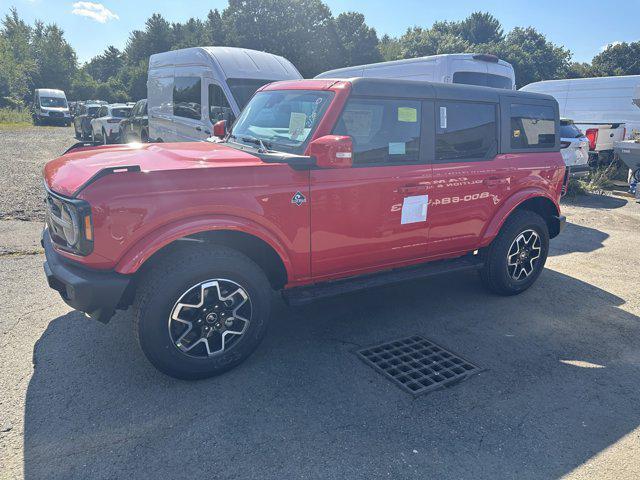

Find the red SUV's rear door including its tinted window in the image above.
[{"left": 429, "top": 101, "right": 512, "bottom": 257}]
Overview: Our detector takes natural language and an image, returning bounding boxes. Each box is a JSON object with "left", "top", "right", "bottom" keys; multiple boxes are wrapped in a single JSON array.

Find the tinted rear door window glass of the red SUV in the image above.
[{"left": 436, "top": 101, "right": 498, "bottom": 162}]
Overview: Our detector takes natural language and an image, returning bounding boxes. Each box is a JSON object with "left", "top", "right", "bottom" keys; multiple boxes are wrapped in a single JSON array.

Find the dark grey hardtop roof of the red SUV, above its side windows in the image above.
[{"left": 336, "top": 77, "right": 556, "bottom": 103}]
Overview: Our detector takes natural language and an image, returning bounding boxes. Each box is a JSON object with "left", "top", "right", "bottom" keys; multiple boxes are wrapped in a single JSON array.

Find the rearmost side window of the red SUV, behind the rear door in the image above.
[{"left": 510, "top": 103, "right": 556, "bottom": 149}]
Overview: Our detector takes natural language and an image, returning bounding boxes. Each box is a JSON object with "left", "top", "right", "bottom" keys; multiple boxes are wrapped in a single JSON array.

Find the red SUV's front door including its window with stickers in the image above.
[{"left": 310, "top": 97, "right": 433, "bottom": 279}]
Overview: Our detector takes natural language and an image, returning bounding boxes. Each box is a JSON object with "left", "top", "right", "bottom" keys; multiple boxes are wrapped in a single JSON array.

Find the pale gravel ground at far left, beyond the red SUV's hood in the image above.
[{"left": 0, "top": 127, "right": 77, "bottom": 220}]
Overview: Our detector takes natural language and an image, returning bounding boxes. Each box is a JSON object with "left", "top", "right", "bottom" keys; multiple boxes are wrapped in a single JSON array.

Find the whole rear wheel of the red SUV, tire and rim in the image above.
[{"left": 480, "top": 210, "right": 549, "bottom": 295}]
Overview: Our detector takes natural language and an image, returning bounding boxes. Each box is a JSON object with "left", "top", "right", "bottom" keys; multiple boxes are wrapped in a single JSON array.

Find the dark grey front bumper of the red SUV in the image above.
[{"left": 41, "top": 229, "right": 132, "bottom": 323}]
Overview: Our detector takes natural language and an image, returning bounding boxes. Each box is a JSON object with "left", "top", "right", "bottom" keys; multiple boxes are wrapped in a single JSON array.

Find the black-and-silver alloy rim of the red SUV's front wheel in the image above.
[{"left": 168, "top": 278, "right": 252, "bottom": 358}]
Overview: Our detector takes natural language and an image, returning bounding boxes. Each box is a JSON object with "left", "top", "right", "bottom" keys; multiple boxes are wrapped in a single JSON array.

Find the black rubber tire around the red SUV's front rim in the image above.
[{"left": 133, "top": 245, "right": 272, "bottom": 380}]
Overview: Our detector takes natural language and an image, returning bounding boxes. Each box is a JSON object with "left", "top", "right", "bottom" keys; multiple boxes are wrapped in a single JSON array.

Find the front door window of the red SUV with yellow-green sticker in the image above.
[{"left": 333, "top": 98, "right": 421, "bottom": 165}]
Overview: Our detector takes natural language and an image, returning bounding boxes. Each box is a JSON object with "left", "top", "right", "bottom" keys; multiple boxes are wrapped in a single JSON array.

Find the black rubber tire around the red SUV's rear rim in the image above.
[{"left": 480, "top": 210, "right": 549, "bottom": 296}]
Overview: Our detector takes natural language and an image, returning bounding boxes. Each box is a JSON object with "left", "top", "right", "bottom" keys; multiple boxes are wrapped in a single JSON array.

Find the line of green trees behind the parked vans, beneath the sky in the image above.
[{"left": 0, "top": 0, "right": 640, "bottom": 106}]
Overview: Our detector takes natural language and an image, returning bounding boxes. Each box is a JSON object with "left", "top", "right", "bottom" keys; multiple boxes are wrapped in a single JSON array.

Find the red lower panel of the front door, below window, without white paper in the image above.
[{"left": 310, "top": 164, "right": 431, "bottom": 278}]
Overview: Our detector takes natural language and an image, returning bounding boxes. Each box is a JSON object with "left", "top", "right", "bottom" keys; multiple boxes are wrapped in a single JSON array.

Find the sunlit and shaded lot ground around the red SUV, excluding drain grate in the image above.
[{"left": 0, "top": 128, "right": 640, "bottom": 479}]
